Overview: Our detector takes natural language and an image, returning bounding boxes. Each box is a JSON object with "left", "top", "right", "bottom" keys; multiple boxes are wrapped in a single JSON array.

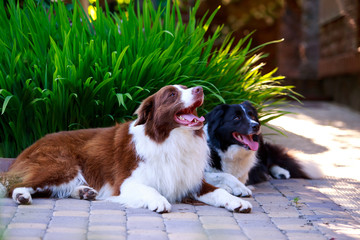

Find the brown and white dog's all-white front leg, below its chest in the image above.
[{"left": 106, "top": 179, "right": 171, "bottom": 213}]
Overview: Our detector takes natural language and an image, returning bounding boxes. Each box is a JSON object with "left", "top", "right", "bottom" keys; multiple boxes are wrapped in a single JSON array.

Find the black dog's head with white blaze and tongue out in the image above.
[{"left": 206, "top": 101, "right": 260, "bottom": 151}]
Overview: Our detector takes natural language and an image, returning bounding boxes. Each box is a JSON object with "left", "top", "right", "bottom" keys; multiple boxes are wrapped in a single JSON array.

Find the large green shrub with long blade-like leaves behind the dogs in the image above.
[{"left": 0, "top": 0, "right": 296, "bottom": 157}]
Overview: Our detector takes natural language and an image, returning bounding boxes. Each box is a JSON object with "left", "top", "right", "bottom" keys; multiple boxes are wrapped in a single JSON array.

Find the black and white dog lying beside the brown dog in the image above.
[{"left": 205, "top": 101, "right": 309, "bottom": 196}]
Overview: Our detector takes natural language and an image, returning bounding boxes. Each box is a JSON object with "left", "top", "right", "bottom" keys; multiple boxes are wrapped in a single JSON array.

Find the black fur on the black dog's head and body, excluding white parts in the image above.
[{"left": 205, "top": 101, "right": 309, "bottom": 184}]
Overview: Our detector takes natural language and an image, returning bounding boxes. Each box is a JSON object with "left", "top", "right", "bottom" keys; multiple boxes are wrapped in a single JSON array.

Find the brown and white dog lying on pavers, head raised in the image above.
[{"left": 8, "top": 85, "right": 251, "bottom": 212}]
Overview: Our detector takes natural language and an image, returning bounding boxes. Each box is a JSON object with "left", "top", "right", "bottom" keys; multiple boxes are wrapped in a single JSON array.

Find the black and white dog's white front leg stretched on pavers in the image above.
[{"left": 205, "top": 172, "right": 252, "bottom": 197}]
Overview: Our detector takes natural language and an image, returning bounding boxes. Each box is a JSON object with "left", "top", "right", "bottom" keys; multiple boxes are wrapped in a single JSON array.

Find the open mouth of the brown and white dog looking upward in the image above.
[{"left": 174, "top": 101, "right": 205, "bottom": 127}]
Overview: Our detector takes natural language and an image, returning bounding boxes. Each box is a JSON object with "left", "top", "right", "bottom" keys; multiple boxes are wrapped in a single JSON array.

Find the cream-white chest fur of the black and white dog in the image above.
[{"left": 217, "top": 145, "right": 257, "bottom": 184}]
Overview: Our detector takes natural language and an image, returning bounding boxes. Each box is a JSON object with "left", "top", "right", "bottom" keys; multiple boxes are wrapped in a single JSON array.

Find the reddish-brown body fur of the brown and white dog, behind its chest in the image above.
[{"left": 9, "top": 122, "right": 138, "bottom": 194}]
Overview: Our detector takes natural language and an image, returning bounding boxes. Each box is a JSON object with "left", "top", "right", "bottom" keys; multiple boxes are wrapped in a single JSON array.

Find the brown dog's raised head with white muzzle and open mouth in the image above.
[{"left": 135, "top": 85, "right": 205, "bottom": 143}]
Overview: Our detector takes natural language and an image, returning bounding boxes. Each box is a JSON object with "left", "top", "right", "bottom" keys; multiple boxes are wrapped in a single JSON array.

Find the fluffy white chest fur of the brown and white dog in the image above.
[{"left": 129, "top": 123, "right": 209, "bottom": 202}]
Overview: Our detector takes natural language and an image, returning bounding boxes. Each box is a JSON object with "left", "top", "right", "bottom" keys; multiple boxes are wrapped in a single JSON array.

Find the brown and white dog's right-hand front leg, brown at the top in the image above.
[{"left": 194, "top": 180, "right": 252, "bottom": 213}]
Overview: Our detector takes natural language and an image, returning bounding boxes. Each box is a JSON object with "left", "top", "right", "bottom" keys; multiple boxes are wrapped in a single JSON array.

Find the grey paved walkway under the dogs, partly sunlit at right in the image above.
[{"left": 0, "top": 103, "right": 360, "bottom": 240}]
